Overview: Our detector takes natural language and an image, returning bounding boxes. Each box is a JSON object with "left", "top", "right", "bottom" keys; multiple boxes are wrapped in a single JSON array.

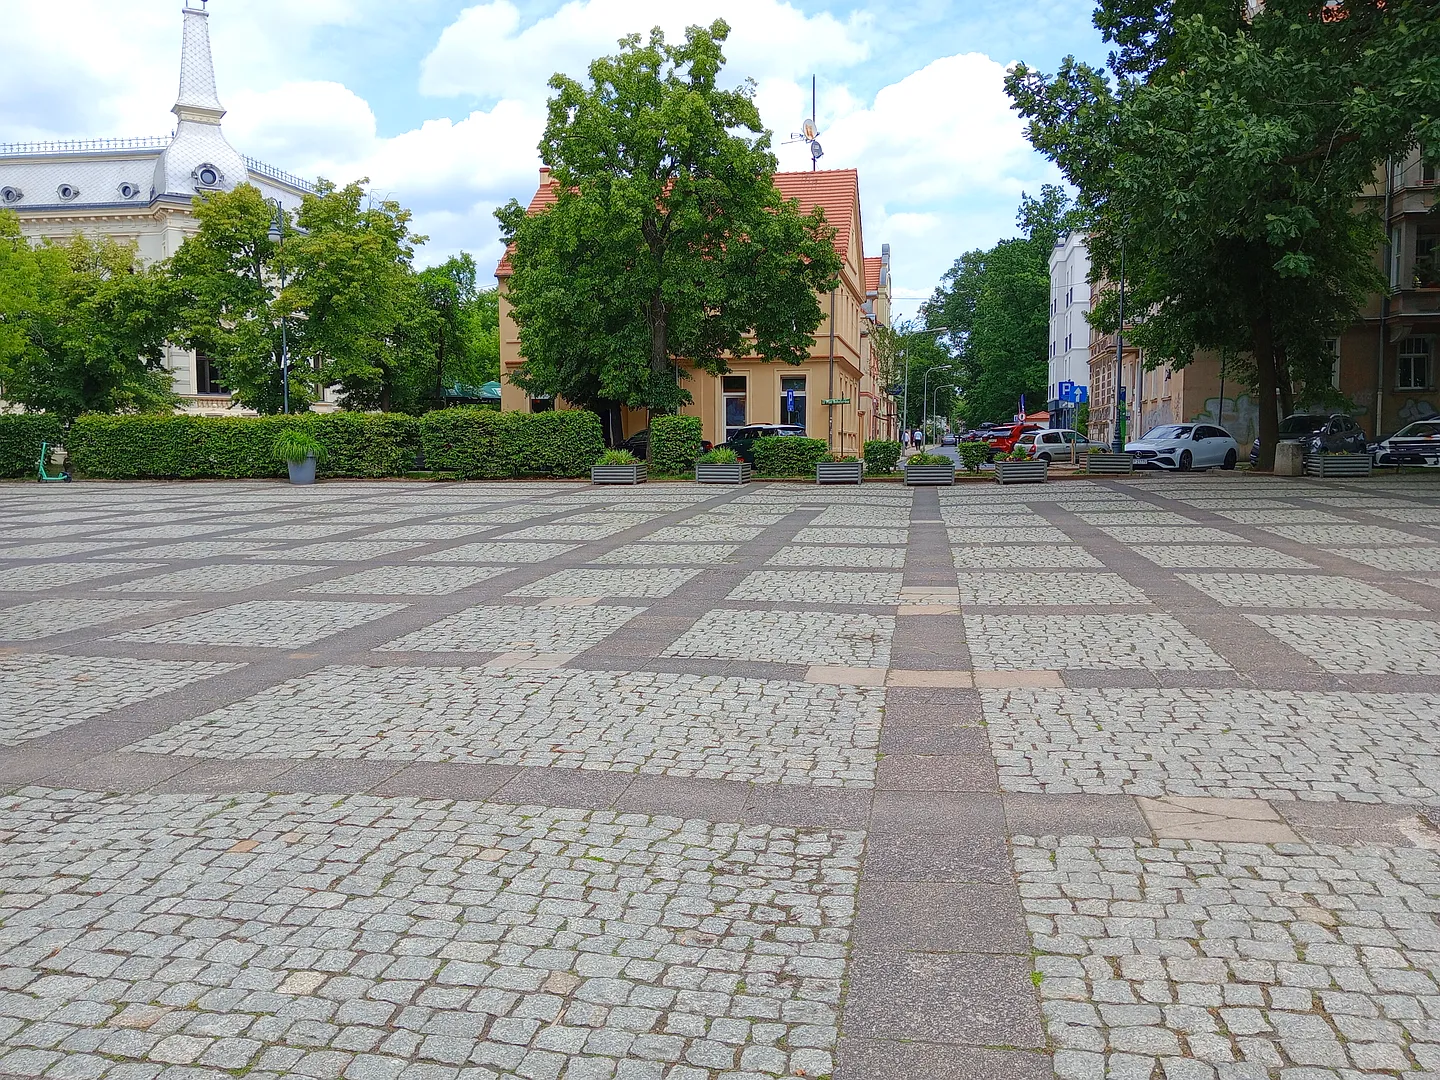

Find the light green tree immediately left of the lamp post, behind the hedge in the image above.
[{"left": 168, "top": 184, "right": 315, "bottom": 413}]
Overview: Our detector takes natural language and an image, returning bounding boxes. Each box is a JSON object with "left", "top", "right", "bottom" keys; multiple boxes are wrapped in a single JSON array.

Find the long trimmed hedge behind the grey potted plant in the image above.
[{"left": 66, "top": 413, "right": 419, "bottom": 480}]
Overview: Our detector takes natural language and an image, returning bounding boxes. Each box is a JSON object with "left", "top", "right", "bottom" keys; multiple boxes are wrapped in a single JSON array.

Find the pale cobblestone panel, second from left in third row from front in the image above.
[{"left": 108, "top": 600, "right": 405, "bottom": 649}]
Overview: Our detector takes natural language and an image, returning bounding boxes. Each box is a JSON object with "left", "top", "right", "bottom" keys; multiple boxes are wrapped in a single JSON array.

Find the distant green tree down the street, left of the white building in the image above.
[{"left": 923, "top": 184, "right": 1070, "bottom": 423}]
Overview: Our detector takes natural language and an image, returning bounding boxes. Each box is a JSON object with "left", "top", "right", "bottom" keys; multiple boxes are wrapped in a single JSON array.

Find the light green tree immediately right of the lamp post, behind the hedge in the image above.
[{"left": 292, "top": 179, "right": 429, "bottom": 412}]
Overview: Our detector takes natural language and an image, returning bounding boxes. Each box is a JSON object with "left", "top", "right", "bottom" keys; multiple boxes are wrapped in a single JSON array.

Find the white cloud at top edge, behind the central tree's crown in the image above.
[{"left": 420, "top": 0, "right": 870, "bottom": 98}]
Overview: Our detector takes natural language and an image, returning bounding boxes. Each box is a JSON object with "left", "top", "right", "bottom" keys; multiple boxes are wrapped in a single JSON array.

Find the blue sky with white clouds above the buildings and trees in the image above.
[{"left": 0, "top": 0, "right": 1104, "bottom": 305}]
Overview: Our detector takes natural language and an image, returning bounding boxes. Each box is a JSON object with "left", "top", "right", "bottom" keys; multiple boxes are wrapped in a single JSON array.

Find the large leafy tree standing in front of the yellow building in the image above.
[{"left": 497, "top": 20, "right": 840, "bottom": 410}]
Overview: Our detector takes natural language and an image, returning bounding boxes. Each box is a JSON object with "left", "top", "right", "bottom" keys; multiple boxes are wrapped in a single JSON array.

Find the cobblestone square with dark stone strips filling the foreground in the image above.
[{"left": 0, "top": 474, "right": 1440, "bottom": 1080}]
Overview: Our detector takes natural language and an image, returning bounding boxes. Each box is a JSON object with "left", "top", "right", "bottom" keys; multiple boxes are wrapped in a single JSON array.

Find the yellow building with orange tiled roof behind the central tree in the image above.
[{"left": 495, "top": 168, "right": 896, "bottom": 454}]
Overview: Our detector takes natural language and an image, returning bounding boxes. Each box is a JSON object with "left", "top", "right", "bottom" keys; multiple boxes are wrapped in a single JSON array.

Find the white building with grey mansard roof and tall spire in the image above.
[{"left": 0, "top": 0, "right": 315, "bottom": 412}]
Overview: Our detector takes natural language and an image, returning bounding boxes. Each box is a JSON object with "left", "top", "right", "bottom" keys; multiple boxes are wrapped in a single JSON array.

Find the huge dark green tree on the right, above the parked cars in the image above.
[{"left": 1007, "top": 0, "right": 1440, "bottom": 467}]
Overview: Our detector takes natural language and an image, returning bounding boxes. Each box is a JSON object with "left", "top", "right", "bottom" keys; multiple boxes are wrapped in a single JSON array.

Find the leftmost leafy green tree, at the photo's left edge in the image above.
[{"left": 0, "top": 213, "right": 174, "bottom": 418}]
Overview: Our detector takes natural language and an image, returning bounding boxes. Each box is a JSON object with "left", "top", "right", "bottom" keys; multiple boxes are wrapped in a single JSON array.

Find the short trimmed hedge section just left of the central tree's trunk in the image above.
[{"left": 420, "top": 408, "right": 605, "bottom": 480}]
